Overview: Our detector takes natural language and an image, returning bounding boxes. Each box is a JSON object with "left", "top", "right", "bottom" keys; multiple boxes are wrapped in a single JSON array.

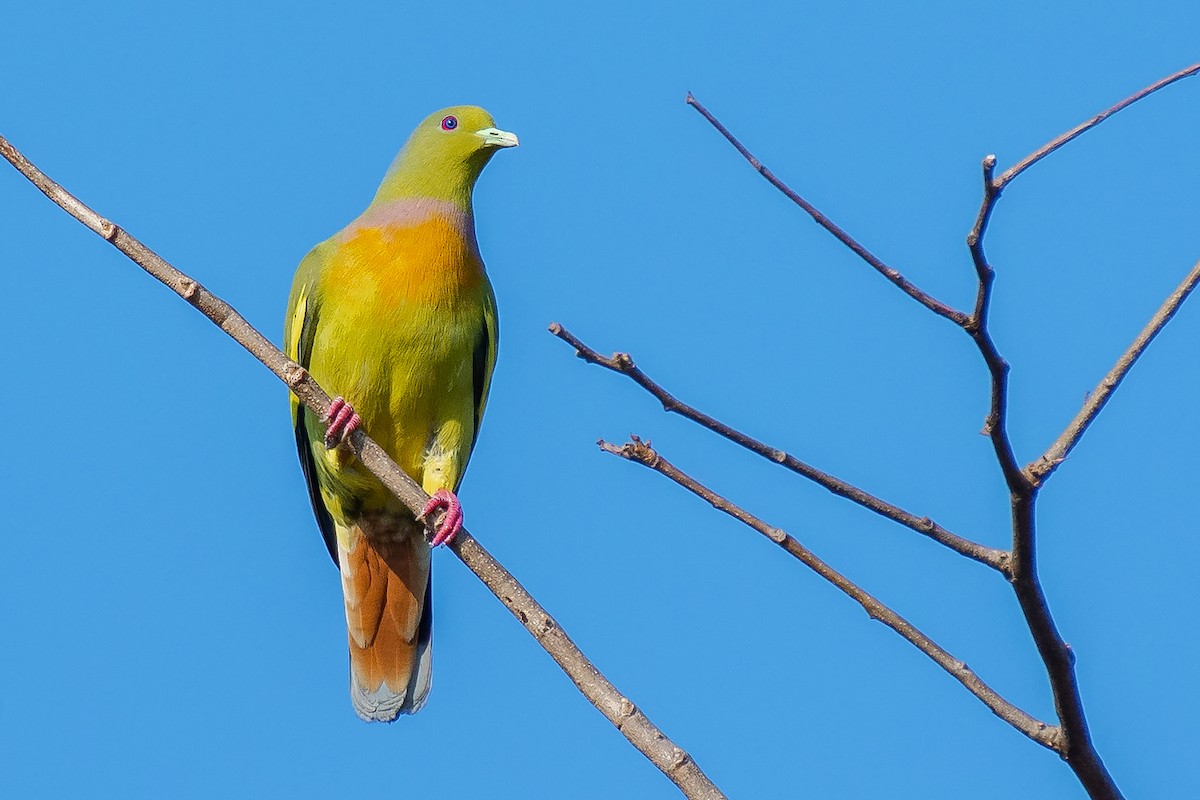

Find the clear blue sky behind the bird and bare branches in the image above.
[{"left": 0, "top": 0, "right": 1200, "bottom": 799}]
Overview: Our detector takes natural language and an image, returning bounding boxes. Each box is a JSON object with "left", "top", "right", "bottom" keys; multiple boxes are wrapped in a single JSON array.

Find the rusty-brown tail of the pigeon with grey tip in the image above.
[{"left": 337, "top": 515, "right": 433, "bottom": 722}]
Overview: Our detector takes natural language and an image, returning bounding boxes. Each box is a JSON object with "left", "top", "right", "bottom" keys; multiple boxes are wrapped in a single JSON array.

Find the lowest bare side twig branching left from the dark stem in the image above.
[{"left": 599, "top": 435, "right": 1058, "bottom": 751}]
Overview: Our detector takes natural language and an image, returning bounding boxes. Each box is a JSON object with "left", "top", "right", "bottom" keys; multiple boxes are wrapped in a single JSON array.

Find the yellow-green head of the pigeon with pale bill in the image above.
[{"left": 376, "top": 106, "right": 517, "bottom": 207}]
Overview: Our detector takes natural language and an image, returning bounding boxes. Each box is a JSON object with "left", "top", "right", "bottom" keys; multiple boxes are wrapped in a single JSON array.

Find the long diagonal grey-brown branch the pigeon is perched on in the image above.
[{"left": 0, "top": 137, "right": 725, "bottom": 800}]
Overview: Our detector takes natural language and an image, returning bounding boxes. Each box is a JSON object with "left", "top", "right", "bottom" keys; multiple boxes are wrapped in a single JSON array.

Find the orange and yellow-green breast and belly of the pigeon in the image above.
[{"left": 312, "top": 200, "right": 488, "bottom": 489}]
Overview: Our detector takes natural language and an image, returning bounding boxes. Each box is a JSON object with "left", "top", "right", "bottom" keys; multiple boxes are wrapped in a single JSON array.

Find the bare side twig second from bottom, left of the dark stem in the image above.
[{"left": 550, "top": 323, "right": 1009, "bottom": 576}]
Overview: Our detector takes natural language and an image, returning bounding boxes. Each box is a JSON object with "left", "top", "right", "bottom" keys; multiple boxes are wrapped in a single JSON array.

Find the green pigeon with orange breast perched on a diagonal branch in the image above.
[{"left": 284, "top": 106, "right": 518, "bottom": 722}]
